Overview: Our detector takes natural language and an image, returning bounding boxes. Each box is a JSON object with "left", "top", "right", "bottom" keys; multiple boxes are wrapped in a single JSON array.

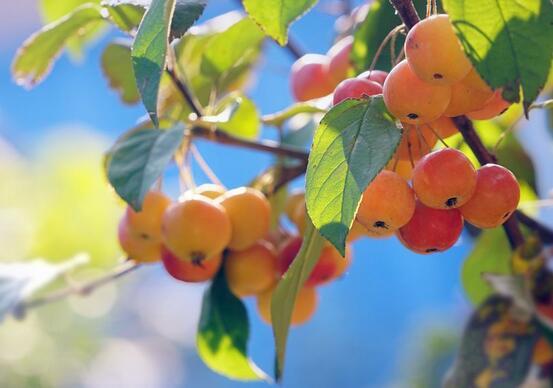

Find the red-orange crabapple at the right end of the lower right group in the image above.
[{"left": 459, "top": 164, "right": 520, "bottom": 228}]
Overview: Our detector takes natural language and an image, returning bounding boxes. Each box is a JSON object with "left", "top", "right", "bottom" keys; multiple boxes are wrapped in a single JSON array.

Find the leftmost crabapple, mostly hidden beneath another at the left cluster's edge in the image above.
[{"left": 117, "top": 216, "right": 161, "bottom": 263}]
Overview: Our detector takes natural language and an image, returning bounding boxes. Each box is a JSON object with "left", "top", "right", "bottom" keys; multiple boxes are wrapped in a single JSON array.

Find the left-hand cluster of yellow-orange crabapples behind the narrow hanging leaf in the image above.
[{"left": 118, "top": 184, "right": 350, "bottom": 325}]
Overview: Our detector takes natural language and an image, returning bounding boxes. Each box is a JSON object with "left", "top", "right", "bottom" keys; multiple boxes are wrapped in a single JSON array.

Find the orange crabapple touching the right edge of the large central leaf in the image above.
[{"left": 356, "top": 170, "right": 415, "bottom": 236}]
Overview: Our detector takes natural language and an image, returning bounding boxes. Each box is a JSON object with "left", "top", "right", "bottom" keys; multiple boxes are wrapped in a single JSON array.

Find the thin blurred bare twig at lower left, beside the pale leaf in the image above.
[{"left": 16, "top": 261, "right": 140, "bottom": 313}]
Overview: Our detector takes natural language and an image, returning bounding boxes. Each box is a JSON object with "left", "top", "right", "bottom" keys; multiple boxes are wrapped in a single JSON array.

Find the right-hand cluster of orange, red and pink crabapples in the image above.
[{"left": 291, "top": 15, "right": 520, "bottom": 253}]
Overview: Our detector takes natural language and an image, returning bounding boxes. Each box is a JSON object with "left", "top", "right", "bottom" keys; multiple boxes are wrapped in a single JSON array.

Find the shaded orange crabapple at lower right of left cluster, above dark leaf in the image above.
[{"left": 225, "top": 241, "right": 278, "bottom": 297}]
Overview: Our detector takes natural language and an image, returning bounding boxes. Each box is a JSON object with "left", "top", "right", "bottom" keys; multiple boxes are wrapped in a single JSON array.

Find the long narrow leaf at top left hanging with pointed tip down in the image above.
[{"left": 131, "top": 0, "right": 175, "bottom": 127}]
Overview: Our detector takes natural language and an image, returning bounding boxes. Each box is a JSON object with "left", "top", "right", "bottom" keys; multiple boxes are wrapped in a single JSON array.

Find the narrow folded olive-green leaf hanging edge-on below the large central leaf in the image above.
[{"left": 271, "top": 217, "right": 325, "bottom": 381}]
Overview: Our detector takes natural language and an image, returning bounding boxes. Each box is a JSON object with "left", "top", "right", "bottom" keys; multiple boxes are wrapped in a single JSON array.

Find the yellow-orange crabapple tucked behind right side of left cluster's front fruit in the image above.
[{"left": 217, "top": 187, "right": 271, "bottom": 251}]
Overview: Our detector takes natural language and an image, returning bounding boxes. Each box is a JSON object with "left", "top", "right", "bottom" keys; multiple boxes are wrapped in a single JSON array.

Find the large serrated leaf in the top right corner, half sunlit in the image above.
[{"left": 444, "top": 0, "right": 553, "bottom": 108}]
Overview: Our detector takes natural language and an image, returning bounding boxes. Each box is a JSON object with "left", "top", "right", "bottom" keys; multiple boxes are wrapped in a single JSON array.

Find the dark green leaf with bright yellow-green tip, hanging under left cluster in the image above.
[{"left": 196, "top": 270, "right": 269, "bottom": 381}]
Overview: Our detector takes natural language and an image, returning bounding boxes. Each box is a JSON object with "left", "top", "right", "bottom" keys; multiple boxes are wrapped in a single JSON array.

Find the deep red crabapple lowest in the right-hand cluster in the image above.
[{"left": 397, "top": 201, "right": 463, "bottom": 254}]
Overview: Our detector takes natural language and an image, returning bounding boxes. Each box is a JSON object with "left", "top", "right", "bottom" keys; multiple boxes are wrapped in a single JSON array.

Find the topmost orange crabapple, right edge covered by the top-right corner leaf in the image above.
[{"left": 405, "top": 15, "right": 472, "bottom": 85}]
